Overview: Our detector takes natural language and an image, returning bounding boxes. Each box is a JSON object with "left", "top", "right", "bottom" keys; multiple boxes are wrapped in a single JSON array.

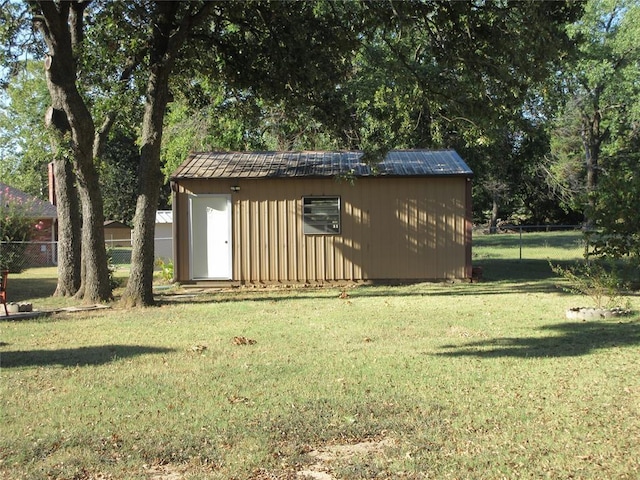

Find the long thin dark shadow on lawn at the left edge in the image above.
[{"left": 0, "top": 345, "right": 173, "bottom": 368}]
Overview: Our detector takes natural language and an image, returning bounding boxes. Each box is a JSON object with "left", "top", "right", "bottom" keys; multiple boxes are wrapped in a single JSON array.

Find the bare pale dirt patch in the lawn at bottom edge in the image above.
[{"left": 297, "top": 438, "right": 395, "bottom": 480}]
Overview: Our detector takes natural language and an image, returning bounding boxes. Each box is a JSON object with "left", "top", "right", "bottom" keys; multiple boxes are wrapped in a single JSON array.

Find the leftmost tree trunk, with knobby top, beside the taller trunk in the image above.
[{"left": 53, "top": 155, "right": 82, "bottom": 297}]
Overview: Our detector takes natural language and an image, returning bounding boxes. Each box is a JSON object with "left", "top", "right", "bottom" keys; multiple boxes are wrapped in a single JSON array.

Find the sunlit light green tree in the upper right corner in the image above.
[{"left": 550, "top": 0, "right": 640, "bottom": 221}]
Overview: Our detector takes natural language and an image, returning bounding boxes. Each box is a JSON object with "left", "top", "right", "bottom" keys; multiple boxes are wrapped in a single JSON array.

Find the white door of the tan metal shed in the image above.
[{"left": 189, "top": 195, "right": 231, "bottom": 280}]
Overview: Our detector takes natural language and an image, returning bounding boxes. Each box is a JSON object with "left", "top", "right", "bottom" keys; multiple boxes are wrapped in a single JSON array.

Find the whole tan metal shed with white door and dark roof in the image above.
[{"left": 171, "top": 150, "right": 473, "bottom": 284}]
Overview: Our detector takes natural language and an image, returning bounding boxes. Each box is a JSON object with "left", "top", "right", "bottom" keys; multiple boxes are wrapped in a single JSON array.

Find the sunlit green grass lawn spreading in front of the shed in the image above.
[{"left": 0, "top": 234, "right": 640, "bottom": 480}]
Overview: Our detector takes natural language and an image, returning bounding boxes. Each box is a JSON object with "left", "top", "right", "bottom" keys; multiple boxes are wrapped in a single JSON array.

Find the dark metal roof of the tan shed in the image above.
[{"left": 171, "top": 150, "right": 473, "bottom": 180}]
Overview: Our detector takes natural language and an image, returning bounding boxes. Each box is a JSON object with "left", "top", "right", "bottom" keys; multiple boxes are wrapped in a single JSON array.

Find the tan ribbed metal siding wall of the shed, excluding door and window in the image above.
[{"left": 175, "top": 177, "right": 469, "bottom": 283}]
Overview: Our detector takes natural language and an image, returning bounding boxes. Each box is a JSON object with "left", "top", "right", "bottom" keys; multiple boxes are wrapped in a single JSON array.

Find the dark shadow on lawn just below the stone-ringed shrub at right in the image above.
[{"left": 436, "top": 319, "right": 640, "bottom": 358}]
